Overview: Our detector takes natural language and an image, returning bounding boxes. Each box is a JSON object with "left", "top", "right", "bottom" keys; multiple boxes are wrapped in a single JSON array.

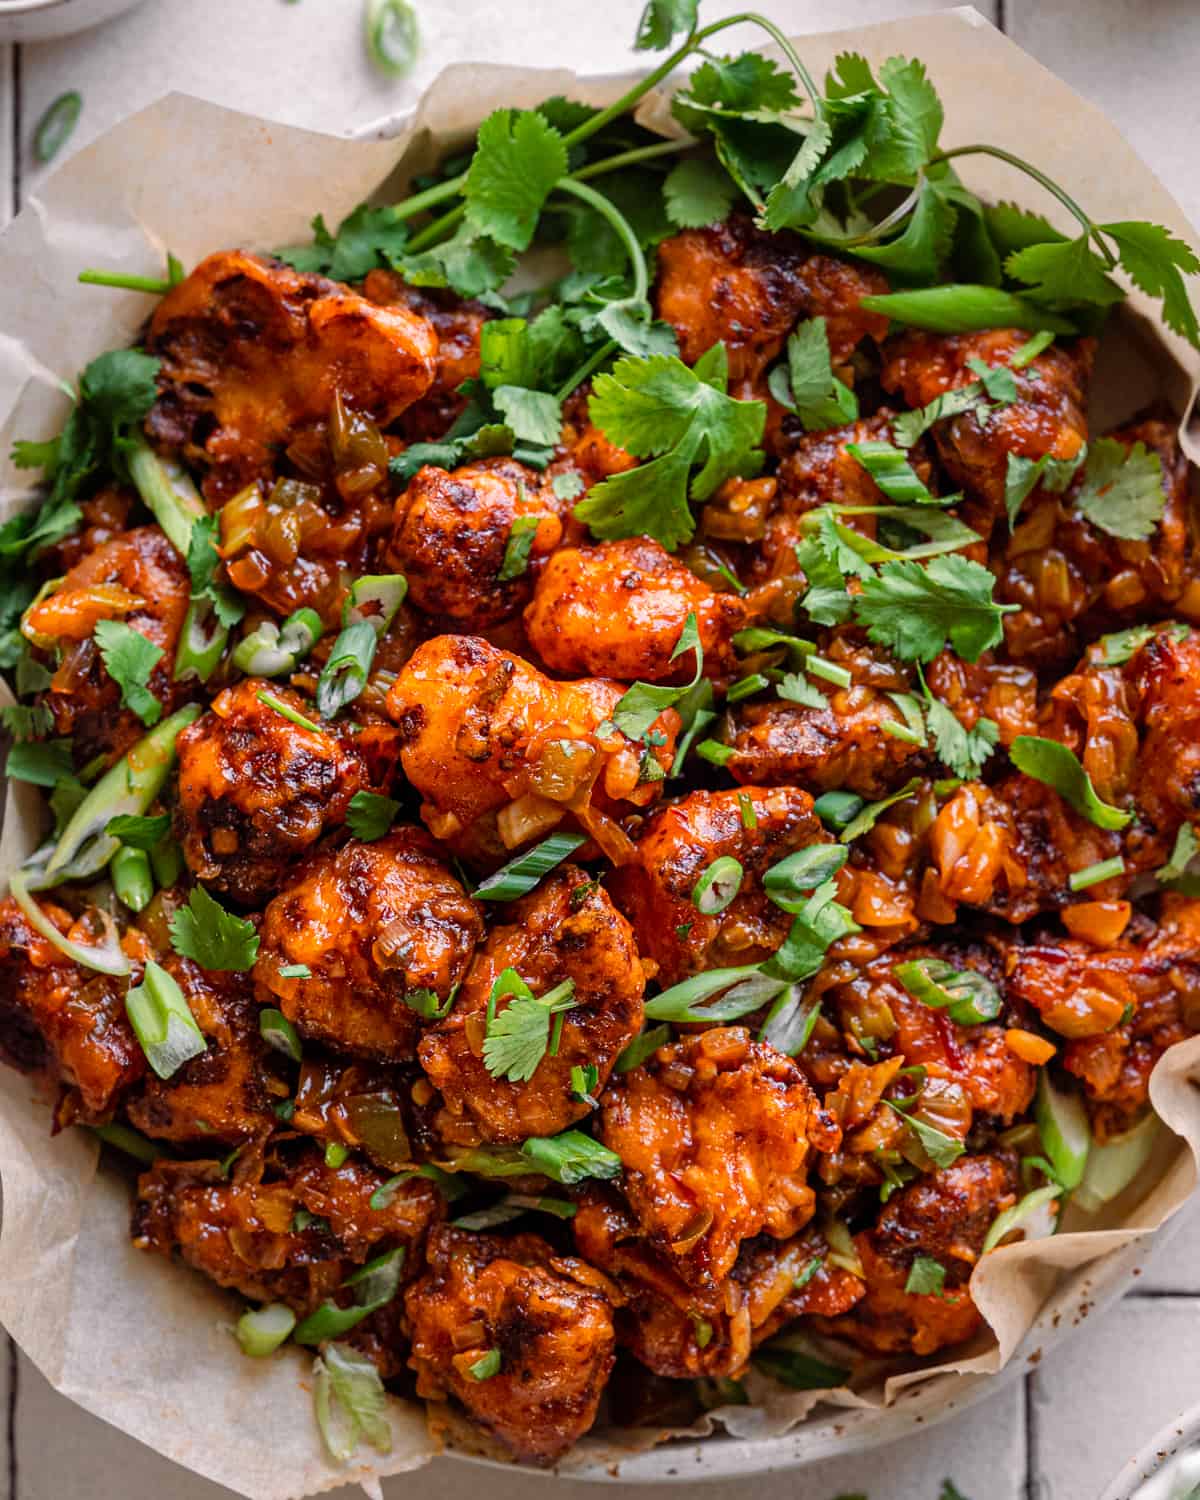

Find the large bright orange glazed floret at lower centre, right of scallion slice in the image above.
[{"left": 602, "top": 1026, "right": 816, "bottom": 1287}]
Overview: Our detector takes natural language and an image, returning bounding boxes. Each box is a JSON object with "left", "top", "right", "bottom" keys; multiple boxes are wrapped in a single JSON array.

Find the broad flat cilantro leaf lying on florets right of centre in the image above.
[{"left": 854, "top": 554, "right": 1016, "bottom": 662}]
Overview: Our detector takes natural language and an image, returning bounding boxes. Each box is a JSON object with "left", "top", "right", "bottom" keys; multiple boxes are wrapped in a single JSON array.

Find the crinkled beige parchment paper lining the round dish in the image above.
[{"left": 0, "top": 11, "right": 1200, "bottom": 1500}]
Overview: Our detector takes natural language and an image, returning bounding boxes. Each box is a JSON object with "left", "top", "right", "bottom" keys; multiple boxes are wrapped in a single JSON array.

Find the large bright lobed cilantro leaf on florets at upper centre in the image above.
[{"left": 575, "top": 344, "right": 767, "bottom": 551}]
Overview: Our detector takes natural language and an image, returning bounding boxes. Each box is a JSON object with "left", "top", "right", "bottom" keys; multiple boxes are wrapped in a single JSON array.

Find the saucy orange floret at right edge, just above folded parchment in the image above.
[{"left": 1008, "top": 891, "right": 1200, "bottom": 1140}]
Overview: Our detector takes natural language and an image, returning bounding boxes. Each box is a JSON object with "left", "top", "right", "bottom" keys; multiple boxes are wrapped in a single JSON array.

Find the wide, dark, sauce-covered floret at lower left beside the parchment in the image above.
[{"left": 132, "top": 1148, "right": 444, "bottom": 1317}]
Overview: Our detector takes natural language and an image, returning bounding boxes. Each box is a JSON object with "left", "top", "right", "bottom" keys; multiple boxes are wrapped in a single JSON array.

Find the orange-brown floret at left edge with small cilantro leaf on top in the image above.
[{"left": 23, "top": 527, "right": 189, "bottom": 765}]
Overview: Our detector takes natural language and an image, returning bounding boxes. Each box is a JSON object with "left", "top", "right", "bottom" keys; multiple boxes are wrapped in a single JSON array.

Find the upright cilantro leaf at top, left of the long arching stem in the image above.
[{"left": 464, "top": 110, "right": 567, "bottom": 251}]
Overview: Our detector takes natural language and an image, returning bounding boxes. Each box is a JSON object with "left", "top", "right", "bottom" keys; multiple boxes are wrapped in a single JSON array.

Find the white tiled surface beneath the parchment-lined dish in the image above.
[{"left": 0, "top": 0, "right": 1200, "bottom": 1500}]
